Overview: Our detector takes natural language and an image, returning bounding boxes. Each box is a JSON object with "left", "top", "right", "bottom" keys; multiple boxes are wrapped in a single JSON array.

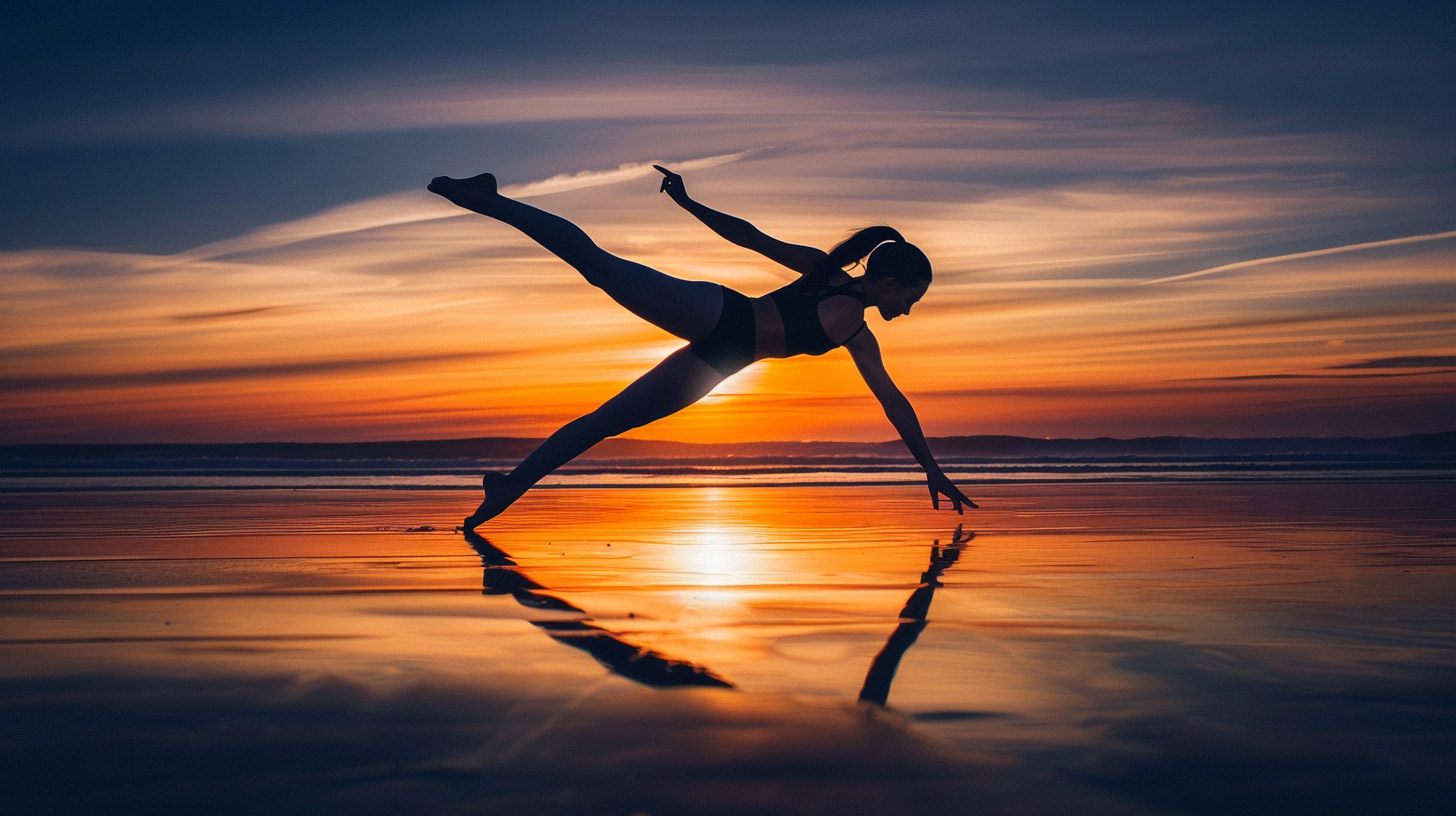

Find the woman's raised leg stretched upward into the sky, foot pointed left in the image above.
[{"left": 430, "top": 173, "right": 722, "bottom": 340}]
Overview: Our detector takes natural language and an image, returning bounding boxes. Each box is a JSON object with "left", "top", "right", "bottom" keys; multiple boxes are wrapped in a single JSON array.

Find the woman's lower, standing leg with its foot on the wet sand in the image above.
[{"left": 464, "top": 348, "right": 724, "bottom": 530}]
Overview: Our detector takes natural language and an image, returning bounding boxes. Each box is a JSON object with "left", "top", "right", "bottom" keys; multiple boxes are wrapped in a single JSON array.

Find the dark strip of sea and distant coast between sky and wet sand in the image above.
[{"left": 0, "top": 431, "right": 1456, "bottom": 491}]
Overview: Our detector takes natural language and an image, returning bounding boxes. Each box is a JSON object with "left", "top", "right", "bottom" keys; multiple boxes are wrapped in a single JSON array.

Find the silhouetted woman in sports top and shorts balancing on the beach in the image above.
[{"left": 430, "top": 168, "right": 976, "bottom": 530}]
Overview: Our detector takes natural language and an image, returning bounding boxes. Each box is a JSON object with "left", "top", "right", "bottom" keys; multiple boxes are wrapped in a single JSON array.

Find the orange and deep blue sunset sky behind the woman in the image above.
[{"left": 0, "top": 0, "right": 1456, "bottom": 443}]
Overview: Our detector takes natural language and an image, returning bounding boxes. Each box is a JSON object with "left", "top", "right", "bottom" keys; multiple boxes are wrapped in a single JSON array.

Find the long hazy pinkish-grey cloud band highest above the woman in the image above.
[{"left": 0, "top": 60, "right": 1361, "bottom": 175}]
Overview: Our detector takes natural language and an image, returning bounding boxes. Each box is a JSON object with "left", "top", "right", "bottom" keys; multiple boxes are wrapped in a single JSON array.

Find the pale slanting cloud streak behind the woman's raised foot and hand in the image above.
[{"left": 173, "top": 147, "right": 766, "bottom": 261}]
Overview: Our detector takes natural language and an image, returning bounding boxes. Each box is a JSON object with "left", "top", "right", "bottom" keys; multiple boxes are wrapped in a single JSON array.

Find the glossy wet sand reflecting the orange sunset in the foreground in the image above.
[{"left": 0, "top": 482, "right": 1456, "bottom": 815}]
